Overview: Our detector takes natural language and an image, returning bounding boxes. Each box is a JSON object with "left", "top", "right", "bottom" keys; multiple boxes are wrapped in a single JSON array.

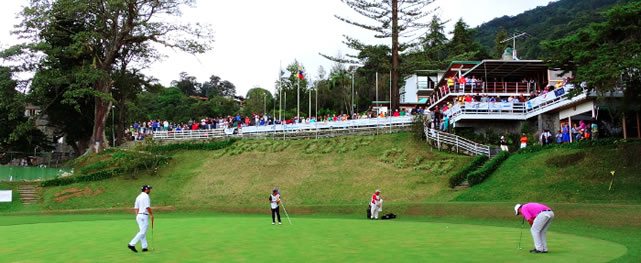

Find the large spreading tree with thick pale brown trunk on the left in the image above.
[{"left": 10, "top": 0, "right": 212, "bottom": 154}]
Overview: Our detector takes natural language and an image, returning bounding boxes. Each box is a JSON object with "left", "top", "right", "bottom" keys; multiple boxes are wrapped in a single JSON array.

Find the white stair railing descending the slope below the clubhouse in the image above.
[{"left": 424, "top": 127, "right": 496, "bottom": 157}]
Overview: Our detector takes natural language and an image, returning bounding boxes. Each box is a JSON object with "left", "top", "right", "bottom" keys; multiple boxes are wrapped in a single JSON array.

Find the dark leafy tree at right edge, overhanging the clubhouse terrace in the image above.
[{"left": 543, "top": 1, "right": 641, "bottom": 115}]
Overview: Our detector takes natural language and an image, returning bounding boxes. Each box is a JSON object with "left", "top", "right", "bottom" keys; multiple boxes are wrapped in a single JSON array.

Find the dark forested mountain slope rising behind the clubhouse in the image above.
[{"left": 475, "top": 0, "right": 635, "bottom": 59}]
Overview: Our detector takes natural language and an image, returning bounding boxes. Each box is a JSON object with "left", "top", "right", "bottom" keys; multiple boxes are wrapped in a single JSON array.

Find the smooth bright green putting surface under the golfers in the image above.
[{"left": 0, "top": 215, "right": 627, "bottom": 262}]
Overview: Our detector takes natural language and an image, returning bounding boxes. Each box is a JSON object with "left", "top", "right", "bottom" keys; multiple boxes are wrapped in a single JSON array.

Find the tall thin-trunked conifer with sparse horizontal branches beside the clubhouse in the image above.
[{"left": 326, "top": 0, "right": 433, "bottom": 111}]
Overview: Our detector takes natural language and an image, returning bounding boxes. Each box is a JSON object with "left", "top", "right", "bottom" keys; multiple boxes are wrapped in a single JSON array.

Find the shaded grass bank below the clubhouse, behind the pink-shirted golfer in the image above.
[{"left": 455, "top": 142, "right": 641, "bottom": 204}]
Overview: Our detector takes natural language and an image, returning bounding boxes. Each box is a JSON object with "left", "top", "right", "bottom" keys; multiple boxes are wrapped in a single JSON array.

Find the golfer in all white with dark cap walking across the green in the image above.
[{"left": 127, "top": 185, "right": 154, "bottom": 253}]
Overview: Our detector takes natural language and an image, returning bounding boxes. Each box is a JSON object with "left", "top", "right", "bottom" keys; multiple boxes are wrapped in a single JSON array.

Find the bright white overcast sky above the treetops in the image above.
[{"left": 0, "top": 0, "right": 552, "bottom": 96}]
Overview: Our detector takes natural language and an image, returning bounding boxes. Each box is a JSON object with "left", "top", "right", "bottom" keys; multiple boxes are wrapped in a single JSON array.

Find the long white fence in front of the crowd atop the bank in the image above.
[{"left": 153, "top": 116, "right": 413, "bottom": 140}]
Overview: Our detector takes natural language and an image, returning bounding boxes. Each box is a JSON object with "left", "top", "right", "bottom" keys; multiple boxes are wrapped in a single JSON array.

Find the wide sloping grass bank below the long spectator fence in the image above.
[{"left": 42, "top": 133, "right": 471, "bottom": 210}]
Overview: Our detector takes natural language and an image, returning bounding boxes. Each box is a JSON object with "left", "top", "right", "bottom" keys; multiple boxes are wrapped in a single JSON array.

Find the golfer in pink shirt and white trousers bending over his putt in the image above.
[{"left": 514, "top": 203, "right": 554, "bottom": 253}]
